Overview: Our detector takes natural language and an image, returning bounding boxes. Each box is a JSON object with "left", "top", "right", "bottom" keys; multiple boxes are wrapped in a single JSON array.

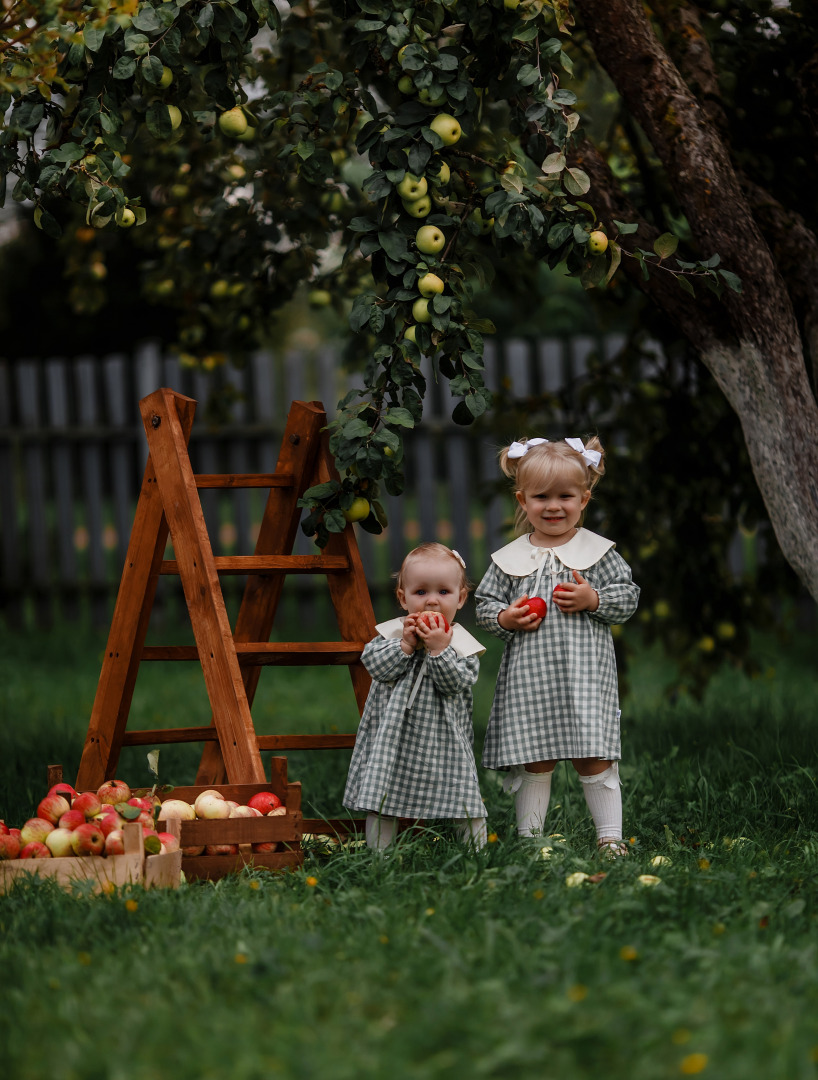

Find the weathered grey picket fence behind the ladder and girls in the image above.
[{"left": 0, "top": 337, "right": 620, "bottom": 626}]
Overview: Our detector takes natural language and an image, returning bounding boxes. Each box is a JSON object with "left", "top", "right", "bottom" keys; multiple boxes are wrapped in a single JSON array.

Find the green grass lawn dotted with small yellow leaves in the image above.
[{"left": 0, "top": 617, "right": 818, "bottom": 1080}]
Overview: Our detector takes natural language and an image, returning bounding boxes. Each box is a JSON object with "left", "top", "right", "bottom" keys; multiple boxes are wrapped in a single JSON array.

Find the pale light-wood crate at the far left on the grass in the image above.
[{"left": 0, "top": 822, "right": 182, "bottom": 893}]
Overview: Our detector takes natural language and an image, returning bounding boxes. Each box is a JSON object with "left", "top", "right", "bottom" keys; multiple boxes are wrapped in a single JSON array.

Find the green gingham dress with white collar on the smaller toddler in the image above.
[{"left": 344, "top": 619, "right": 485, "bottom": 819}]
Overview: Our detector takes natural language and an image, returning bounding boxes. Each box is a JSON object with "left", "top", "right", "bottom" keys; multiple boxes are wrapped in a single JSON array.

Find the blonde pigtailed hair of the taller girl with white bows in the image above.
[{"left": 499, "top": 435, "right": 605, "bottom": 532}]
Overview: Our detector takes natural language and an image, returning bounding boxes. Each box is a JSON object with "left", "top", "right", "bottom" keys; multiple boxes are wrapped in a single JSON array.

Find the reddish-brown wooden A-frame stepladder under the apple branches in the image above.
[{"left": 77, "top": 389, "right": 375, "bottom": 833}]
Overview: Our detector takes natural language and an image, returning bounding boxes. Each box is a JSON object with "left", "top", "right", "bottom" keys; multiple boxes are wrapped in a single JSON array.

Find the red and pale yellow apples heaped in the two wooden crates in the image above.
[{"left": 0, "top": 780, "right": 286, "bottom": 860}]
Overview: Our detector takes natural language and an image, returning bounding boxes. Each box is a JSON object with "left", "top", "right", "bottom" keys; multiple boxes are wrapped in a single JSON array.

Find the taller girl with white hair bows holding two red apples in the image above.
[{"left": 475, "top": 438, "right": 640, "bottom": 855}]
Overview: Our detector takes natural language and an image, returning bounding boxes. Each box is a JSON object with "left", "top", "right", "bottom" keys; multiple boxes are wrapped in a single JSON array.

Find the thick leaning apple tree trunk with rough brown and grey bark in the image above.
[{"left": 575, "top": 0, "right": 818, "bottom": 600}]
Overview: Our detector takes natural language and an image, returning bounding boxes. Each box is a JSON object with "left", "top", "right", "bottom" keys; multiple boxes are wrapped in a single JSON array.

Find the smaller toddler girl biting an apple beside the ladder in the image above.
[{"left": 344, "top": 543, "right": 486, "bottom": 849}]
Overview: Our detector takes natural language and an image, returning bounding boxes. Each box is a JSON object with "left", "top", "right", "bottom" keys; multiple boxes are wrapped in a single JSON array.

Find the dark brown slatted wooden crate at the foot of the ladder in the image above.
[{"left": 158, "top": 757, "right": 304, "bottom": 881}]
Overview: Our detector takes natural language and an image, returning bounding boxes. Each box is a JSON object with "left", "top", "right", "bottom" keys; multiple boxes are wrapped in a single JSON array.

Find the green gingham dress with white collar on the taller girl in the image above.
[{"left": 474, "top": 529, "right": 640, "bottom": 770}]
